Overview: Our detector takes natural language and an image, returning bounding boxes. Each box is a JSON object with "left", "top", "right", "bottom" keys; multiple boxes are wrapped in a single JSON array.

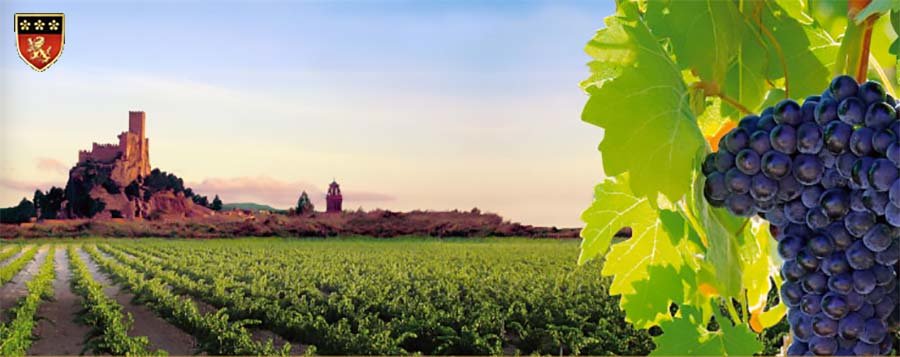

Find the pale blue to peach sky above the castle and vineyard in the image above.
[{"left": 0, "top": 0, "right": 614, "bottom": 227}]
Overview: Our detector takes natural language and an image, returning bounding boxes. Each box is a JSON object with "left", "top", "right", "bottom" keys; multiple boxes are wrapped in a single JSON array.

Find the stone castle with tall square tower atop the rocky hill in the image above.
[{"left": 78, "top": 112, "right": 150, "bottom": 186}]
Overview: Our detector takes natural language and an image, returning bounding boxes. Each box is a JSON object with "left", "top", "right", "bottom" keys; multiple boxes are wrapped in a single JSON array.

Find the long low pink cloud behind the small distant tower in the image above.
[{"left": 188, "top": 176, "right": 395, "bottom": 208}]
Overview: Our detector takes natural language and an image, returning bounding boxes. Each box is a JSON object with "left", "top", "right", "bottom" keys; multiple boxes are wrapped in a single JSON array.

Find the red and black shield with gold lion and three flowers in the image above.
[{"left": 15, "top": 14, "right": 66, "bottom": 72}]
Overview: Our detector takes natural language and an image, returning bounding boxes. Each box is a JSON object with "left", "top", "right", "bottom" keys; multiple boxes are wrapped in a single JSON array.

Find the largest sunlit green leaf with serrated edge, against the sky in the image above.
[{"left": 582, "top": 3, "right": 705, "bottom": 201}]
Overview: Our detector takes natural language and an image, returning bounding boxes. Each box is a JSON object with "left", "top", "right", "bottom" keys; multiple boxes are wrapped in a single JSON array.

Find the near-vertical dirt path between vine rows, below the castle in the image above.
[{"left": 28, "top": 247, "right": 91, "bottom": 355}]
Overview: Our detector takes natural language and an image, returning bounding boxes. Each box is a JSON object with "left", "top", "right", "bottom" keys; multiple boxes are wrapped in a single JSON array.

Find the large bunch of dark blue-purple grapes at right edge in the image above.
[{"left": 702, "top": 76, "right": 900, "bottom": 355}]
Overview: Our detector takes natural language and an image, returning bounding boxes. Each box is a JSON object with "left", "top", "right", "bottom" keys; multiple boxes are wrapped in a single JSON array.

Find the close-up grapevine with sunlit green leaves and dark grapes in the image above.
[{"left": 579, "top": 0, "right": 900, "bottom": 355}]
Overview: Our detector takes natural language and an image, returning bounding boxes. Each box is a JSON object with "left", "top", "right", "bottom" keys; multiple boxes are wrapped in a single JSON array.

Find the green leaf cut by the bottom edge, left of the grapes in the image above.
[{"left": 651, "top": 305, "right": 762, "bottom": 356}]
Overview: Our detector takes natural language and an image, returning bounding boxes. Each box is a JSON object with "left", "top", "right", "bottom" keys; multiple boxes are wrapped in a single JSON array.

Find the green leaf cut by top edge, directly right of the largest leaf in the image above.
[{"left": 645, "top": 0, "right": 743, "bottom": 83}]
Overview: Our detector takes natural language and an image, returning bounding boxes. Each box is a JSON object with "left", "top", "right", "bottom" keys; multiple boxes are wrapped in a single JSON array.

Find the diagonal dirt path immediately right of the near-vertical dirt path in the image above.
[{"left": 78, "top": 249, "right": 195, "bottom": 356}]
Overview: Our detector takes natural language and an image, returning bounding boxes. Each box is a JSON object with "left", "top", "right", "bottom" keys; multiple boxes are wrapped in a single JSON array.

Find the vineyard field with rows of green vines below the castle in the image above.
[{"left": 0, "top": 238, "right": 652, "bottom": 355}]
